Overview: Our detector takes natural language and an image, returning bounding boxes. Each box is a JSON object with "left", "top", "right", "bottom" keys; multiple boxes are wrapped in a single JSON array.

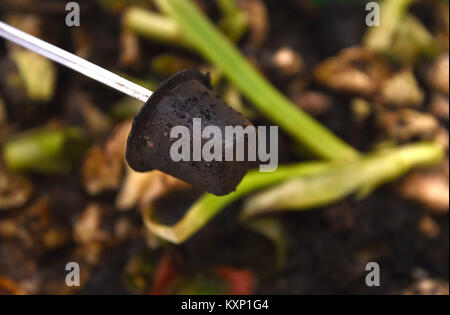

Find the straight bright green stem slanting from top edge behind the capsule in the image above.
[{"left": 156, "top": 0, "right": 358, "bottom": 159}]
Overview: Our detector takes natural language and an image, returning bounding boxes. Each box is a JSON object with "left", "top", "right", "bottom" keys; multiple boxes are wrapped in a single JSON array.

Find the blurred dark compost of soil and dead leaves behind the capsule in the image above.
[{"left": 0, "top": 0, "right": 449, "bottom": 294}]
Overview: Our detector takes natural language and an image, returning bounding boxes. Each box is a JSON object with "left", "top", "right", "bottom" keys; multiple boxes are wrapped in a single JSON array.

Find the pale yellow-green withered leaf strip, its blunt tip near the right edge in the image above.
[{"left": 242, "top": 143, "right": 444, "bottom": 219}]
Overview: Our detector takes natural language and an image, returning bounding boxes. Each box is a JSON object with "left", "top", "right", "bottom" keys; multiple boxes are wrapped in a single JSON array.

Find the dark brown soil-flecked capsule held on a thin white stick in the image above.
[{"left": 126, "top": 70, "right": 255, "bottom": 196}]
